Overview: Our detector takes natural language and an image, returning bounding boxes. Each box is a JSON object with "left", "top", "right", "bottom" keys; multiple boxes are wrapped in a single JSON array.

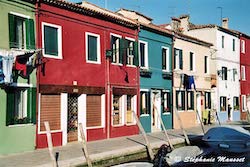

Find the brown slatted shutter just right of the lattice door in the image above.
[{"left": 87, "top": 95, "right": 102, "bottom": 127}]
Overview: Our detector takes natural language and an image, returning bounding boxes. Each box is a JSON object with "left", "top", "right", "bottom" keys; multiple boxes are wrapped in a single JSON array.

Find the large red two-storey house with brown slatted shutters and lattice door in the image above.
[{"left": 36, "top": 0, "right": 139, "bottom": 148}]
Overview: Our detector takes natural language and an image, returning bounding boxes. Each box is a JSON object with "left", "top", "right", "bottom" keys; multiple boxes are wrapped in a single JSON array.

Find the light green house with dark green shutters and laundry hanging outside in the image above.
[{"left": 0, "top": 0, "right": 38, "bottom": 155}]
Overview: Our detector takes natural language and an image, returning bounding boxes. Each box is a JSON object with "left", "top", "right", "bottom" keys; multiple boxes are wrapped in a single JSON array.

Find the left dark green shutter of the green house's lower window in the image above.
[{"left": 6, "top": 91, "right": 15, "bottom": 126}]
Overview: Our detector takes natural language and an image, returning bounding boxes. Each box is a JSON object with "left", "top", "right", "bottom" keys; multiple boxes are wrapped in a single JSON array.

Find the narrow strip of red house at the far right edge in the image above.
[{"left": 240, "top": 34, "right": 250, "bottom": 120}]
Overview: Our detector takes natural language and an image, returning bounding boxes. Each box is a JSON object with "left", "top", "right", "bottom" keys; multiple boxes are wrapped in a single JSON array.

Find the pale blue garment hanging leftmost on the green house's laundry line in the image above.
[{"left": 2, "top": 56, "right": 14, "bottom": 83}]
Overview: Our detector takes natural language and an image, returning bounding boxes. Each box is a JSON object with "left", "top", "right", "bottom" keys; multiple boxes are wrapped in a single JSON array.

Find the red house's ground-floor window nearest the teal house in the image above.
[{"left": 126, "top": 95, "right": 136, "bottom": 124}]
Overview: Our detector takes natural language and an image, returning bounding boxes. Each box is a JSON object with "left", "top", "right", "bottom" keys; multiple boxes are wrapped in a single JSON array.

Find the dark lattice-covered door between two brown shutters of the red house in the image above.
[{"left": 67, "top": 94, "right": 78, "bottom": 142}]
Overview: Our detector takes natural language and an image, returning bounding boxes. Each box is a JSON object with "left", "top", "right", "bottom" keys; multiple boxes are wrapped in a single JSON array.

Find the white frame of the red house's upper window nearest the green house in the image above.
[{"left": 42, "top": 22, "right": 63, "bottom": 59}]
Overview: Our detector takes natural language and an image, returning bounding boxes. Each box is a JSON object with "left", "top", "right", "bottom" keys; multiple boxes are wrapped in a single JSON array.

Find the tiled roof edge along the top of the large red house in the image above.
[{"left": 41, "top": 0, "right": 138, "bottom": 27}]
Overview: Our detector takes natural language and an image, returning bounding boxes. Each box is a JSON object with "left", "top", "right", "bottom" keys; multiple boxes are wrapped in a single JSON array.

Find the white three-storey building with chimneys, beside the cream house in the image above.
[{"left": 187, "top": 18, "right": 240, "bottom": 122}]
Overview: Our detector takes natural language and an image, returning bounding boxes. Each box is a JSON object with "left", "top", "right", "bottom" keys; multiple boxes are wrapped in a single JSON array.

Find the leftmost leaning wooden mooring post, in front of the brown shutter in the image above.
[{"left": 44, "top": 121, "right": 57, "bottom": 167}]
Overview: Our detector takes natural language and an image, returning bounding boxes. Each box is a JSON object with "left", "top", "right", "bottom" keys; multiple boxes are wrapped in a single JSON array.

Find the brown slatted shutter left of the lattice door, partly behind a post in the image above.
[{"left": 40, "top": 94, "right": 61, "bottom": 131}]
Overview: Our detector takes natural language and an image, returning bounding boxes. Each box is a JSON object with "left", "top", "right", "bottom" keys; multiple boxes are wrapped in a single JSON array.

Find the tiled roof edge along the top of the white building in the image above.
[{"left": 189, "top": 23, "right": 240, "bottom": 36}]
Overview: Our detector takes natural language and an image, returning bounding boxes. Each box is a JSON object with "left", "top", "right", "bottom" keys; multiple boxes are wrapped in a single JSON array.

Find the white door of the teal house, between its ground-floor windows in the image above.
[{"left": 151, "top": 90, "right": 161, "bottom": 132}]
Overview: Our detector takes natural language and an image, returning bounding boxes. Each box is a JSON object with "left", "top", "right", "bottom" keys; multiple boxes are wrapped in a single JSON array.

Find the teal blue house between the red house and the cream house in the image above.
[{"left": 118, "top": 9, "right": 173, "bottom": 132}]
